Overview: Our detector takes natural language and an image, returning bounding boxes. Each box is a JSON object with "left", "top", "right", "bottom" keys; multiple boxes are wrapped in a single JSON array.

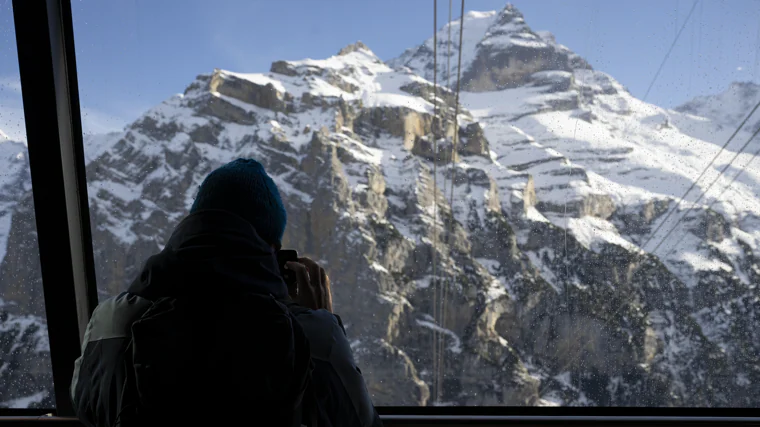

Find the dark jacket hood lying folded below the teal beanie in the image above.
[{"left": 129, "top": 210, "right": 288, "bottom": 299}]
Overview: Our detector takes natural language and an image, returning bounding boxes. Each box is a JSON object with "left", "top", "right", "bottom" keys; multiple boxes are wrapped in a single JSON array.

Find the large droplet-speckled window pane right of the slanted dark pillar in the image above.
[{"left": 73, "top": 0, "right": 760, "bottom": 407}]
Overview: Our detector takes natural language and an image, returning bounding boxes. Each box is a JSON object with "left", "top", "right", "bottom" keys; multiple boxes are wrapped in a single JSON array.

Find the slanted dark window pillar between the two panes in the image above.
[{"left": 12, "top": 0, "right": 97, "bottom": 416}]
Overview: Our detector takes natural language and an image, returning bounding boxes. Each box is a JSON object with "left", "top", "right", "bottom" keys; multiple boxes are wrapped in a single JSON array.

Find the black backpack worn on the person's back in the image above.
[{"left": 115, "top": 293, "right": 317, "bottom": 427}]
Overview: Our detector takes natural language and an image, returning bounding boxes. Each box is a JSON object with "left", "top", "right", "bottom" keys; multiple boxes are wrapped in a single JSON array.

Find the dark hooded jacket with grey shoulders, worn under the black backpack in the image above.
[{"left": 71, "top": 211, "right": 380, "bottom": 426}]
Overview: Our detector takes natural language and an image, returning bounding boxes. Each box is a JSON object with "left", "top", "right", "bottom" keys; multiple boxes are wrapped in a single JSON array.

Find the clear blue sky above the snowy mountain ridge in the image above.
[{"left": 0, "top": 0, "right": 760, "bottom": 142}]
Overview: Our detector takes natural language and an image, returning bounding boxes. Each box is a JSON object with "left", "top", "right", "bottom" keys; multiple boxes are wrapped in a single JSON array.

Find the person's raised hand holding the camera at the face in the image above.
[{"left": 285, "top": 258, "right": 332, "bottom": 313}]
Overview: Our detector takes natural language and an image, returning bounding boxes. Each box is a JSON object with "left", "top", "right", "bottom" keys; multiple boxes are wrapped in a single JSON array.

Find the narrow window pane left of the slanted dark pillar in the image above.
[{"left": 0, "top": 1, "right": 55, "bottom": 408}]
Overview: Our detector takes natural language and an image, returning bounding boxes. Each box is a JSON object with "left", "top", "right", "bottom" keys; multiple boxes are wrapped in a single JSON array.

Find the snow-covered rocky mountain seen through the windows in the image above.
[{"left": 0, "top": 6, "right": 760, "bottom": 412}]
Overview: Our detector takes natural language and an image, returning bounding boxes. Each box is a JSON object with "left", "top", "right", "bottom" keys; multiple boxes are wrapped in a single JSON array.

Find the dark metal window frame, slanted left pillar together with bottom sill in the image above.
[{"left": 0, "top": 0, "right": 760, "bottom": 426}]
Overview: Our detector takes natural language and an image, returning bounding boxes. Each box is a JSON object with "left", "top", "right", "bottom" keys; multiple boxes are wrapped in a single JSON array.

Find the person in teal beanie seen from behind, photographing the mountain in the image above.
[{"left": 70, "top": 159, "right": 381, "bottom": 427}]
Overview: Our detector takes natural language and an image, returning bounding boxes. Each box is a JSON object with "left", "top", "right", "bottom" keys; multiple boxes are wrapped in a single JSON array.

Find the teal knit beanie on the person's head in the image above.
[{"left": 190, "top": 159, "right": 288, "bottom": 247}]
